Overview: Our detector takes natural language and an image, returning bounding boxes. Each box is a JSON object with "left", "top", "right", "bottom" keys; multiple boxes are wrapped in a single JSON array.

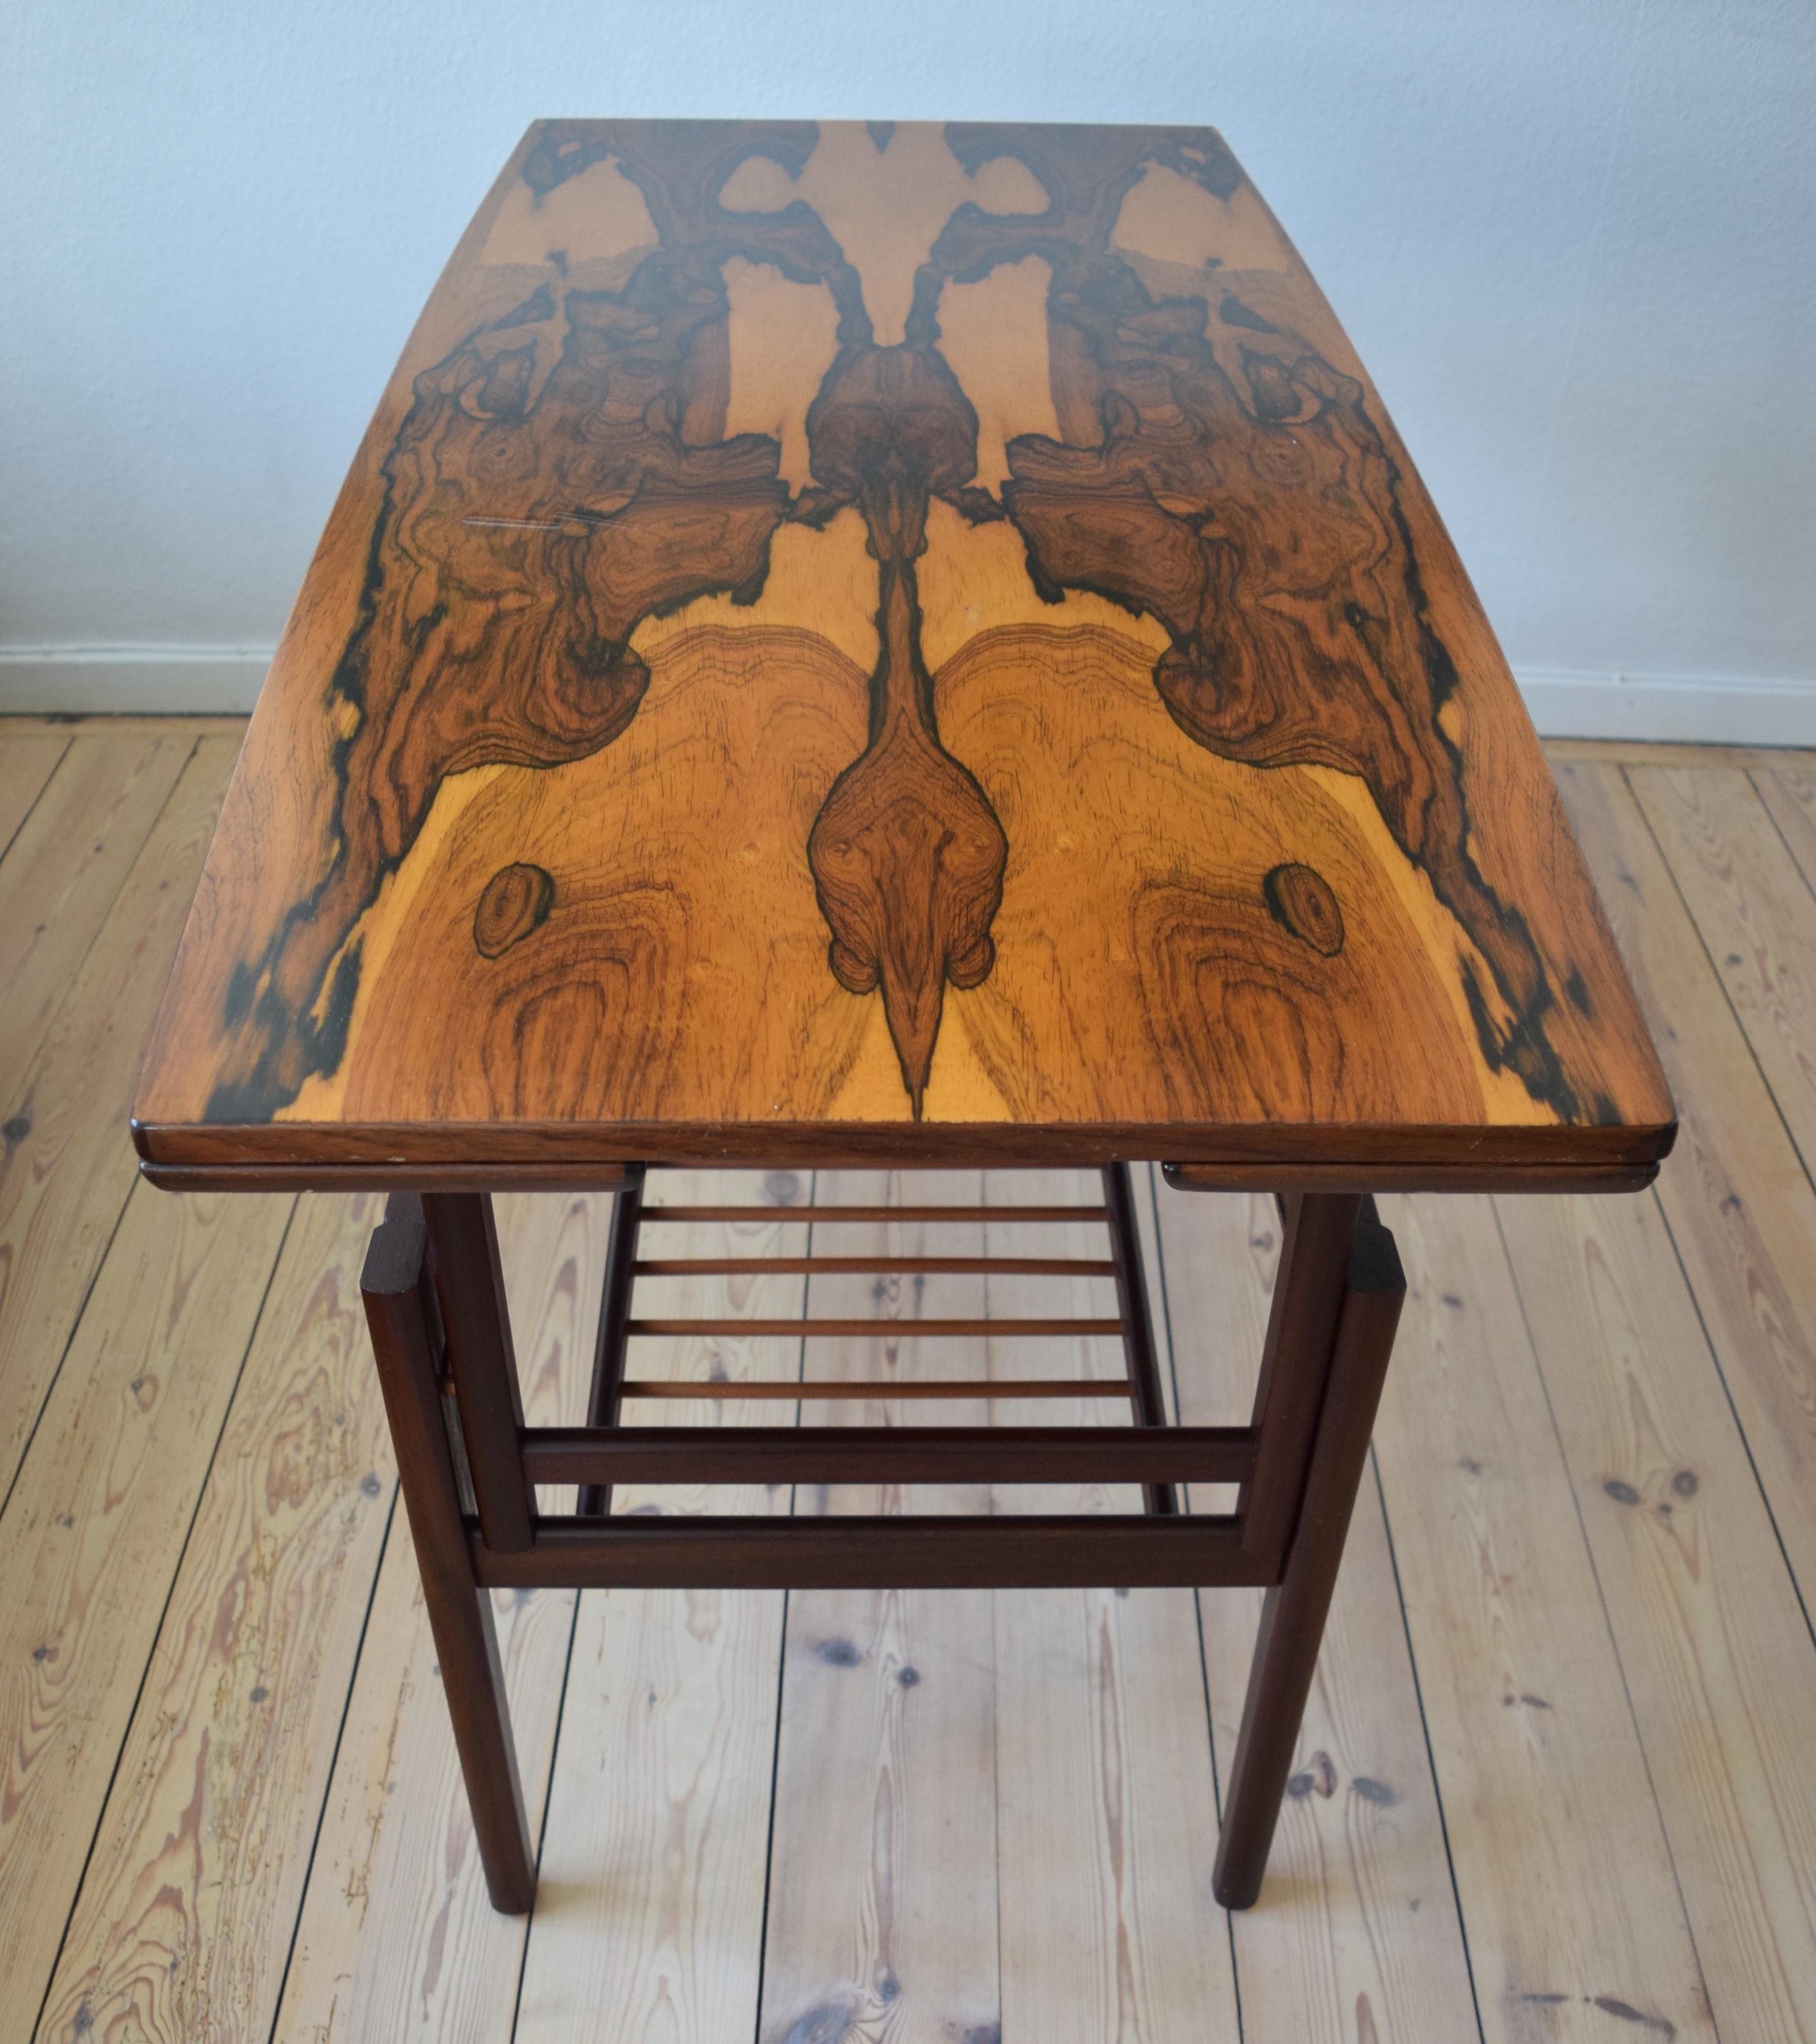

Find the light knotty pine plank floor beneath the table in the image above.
[{"left": 0, "top": 719, "right": 1816, "bottom": 2044}]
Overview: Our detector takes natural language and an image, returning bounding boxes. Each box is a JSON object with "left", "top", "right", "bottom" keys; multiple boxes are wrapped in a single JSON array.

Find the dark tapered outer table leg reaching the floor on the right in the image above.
[{"left": 1211, "top": 1202, "right": 1407, "bottom": 1909}]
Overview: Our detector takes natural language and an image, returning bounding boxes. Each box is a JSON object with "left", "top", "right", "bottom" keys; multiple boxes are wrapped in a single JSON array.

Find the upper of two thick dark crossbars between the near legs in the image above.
[{"left": 523, "top": 1427, "right": 1255, "bottom": 1484}]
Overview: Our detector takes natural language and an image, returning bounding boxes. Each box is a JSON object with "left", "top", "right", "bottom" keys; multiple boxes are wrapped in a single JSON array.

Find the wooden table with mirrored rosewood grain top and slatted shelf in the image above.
[{"left": 135, "top": 121, "right": 1673, "bottom": 1909}]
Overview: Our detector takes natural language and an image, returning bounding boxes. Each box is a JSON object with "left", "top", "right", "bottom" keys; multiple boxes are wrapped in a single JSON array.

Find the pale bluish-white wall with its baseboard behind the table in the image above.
[{"left": 0, "top": 0, "right": 1816, "bottom": 742}]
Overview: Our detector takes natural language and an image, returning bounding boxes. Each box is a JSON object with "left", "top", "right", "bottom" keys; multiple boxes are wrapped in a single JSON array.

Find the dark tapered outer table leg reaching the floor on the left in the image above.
[{"left": 360, "top": 1194, "right": 536, "bottom": 1915}]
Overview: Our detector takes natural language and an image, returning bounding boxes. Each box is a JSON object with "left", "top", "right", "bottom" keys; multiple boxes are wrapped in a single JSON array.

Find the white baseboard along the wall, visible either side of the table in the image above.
[{"left": 0, "top": 646, "right": 1816, "bottom": 746}]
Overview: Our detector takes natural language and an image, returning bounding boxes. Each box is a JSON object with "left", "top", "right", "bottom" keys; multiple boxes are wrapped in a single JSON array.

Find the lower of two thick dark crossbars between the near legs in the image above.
[{"left": 466, "top": 1512, "right": 1280, "bottom": 1590}]
